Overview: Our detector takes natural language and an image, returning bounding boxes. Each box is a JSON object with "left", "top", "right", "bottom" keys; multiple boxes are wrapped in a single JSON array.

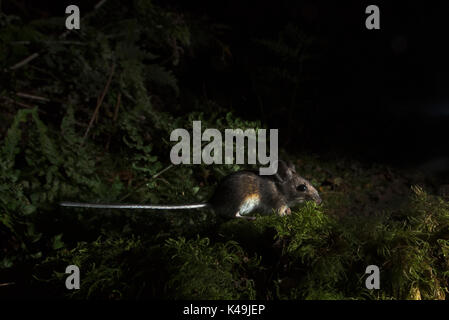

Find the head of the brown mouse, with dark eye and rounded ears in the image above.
[{"left": 276, "top": 160, "right": 322, "bottom": 205}]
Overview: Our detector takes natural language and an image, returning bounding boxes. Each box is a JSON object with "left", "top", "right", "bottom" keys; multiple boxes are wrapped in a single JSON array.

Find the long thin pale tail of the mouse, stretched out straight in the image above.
[{"left": 59, "top": 202, "right": 209, "bottom": 210}]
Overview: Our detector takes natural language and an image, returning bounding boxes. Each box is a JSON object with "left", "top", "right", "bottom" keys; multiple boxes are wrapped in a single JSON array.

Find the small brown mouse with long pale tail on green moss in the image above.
[{"left": 60, "top": 160, "right": 322, "bottom": 220}]
